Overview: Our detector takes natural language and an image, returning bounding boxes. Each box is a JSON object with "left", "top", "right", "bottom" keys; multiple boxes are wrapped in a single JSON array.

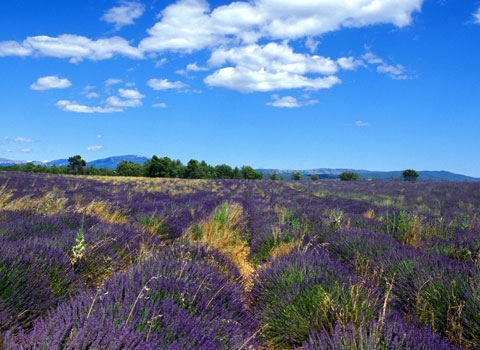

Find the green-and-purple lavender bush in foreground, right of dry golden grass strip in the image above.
[{"left": 252, "top": 240, "right": 381, "bottom": 348}]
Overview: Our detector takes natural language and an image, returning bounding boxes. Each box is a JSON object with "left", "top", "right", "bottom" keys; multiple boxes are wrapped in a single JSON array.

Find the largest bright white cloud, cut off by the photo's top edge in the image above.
[{"left": 139, "top": 0, "right": 423, "bottom": 52}]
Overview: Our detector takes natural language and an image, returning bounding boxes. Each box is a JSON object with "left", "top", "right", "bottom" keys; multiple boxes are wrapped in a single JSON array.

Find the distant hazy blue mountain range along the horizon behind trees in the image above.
[{"left": 0, "top": 155, "right": 480, "bottom": 182}]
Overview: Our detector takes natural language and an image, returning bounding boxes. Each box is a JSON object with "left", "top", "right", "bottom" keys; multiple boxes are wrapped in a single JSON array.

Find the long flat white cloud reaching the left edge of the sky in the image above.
[{"left": 0, "top": 34, "right": 143, "bottom": 63}]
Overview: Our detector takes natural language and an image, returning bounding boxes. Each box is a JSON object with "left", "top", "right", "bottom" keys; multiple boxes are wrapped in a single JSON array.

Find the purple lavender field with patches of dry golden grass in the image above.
[{"left": 0, "top": 172, "right": 480, "bottom": 350}]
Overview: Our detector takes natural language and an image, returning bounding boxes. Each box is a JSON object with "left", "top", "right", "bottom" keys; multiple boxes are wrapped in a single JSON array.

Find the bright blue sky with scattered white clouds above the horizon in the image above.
[{"left": 0, "top": 0, "right": 480, "bottom": 177}]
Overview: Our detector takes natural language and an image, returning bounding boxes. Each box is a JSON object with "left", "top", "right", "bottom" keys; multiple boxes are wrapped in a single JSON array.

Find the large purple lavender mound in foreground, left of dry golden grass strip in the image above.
[{"left": 5, "top": 245, "right": 254, "bottom": 349}]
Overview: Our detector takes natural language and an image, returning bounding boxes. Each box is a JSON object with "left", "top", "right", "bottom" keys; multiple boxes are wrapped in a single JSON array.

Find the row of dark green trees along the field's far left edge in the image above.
[{"left": 0, "top": 155, "right": 263, "bottom": 180}]
